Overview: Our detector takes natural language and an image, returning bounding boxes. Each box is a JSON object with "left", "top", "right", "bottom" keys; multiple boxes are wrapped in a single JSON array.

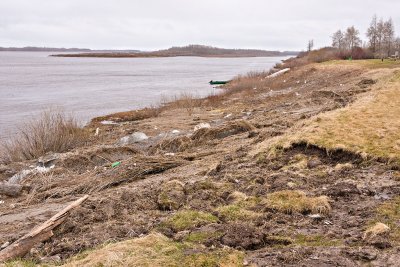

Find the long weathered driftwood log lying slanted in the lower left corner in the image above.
[{"left": 0, "top": 195, "right": 89, "bottom": 262}]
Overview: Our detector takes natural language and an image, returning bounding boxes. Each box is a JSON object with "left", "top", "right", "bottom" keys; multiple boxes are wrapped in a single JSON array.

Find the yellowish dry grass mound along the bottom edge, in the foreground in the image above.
[{"left": 63, "top": 234, "right": 243, "bottom": 267}]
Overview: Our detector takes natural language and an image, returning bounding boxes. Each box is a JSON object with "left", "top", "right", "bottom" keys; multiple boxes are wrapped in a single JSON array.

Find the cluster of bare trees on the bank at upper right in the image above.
[{"left": 332, "top": 15, "right": 400, "bottom": 59}]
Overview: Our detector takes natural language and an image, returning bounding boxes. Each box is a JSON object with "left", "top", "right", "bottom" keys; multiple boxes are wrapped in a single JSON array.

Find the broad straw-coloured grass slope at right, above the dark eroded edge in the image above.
[{"left": 265, "top": 69, "right": 400, "bottom": 164}]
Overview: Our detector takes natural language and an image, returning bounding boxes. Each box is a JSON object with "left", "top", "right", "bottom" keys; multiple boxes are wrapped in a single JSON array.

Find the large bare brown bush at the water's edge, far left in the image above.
[{"left": 0, "top": 110, "right": 88, "bottom": 162}]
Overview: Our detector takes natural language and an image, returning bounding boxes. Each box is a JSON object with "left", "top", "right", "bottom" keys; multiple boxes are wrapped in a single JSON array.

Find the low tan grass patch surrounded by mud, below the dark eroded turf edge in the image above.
[{"left": 264, "top": 190, "right": 331, "bottom": 214}]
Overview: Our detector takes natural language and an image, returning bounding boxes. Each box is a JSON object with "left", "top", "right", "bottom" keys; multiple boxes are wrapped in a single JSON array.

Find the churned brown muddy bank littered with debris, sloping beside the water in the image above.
[{"left": 0, "top": 65, "right": 400, "bottom": 266}]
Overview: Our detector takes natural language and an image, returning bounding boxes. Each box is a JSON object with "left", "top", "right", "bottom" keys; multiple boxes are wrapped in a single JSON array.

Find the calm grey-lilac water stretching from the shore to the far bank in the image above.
[{"left": 0, "top": 52, "right": 284, "bottom": 138}]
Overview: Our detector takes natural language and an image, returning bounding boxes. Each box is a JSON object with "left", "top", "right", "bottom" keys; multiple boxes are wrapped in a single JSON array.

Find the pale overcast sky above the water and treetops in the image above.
[{"left": 0, "top": 0, "right": 400, "bottom": 50}]
